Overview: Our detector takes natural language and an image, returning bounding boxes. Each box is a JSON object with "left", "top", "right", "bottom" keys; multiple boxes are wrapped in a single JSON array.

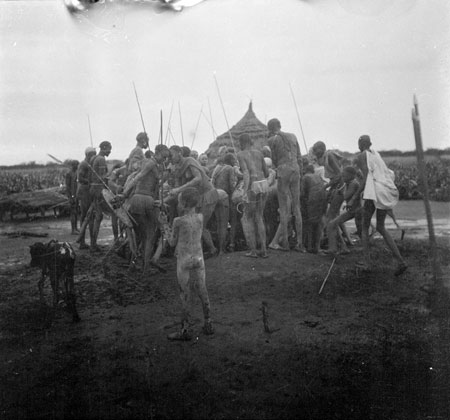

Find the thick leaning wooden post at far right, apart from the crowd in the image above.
[{"left": 412, "top": 95, "right": 442, "bottom": 278}]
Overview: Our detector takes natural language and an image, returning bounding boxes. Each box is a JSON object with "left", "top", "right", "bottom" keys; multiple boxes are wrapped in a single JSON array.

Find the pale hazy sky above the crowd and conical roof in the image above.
[{"left": 0, "top": 0, "right": 450, "bottom": 164}]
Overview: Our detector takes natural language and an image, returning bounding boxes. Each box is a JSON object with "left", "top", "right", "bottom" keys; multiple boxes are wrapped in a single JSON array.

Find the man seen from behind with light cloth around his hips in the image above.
[{"left": 237, "top": 134, "right": 269, "bottom": 258}]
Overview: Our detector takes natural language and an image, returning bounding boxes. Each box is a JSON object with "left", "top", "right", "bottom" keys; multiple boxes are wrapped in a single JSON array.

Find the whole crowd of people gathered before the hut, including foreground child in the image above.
[{"left": 59, "top": 124, "right": 407, "bottom": 340}]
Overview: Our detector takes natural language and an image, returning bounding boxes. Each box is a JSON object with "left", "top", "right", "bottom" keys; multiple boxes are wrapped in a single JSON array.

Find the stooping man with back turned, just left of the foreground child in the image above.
[{"left": 123, "top": 144, "right": 169, "bottom": 273}]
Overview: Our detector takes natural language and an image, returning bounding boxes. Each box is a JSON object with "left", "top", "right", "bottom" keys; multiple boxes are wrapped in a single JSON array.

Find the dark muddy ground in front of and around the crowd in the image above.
[{"left": 0, "top": 203, "right": 450, "bottom": 420}]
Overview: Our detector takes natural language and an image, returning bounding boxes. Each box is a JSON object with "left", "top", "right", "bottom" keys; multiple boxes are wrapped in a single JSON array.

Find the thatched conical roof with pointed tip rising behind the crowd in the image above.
[{"left": 206, "top": 102, "right": 268, "bottom": 158}]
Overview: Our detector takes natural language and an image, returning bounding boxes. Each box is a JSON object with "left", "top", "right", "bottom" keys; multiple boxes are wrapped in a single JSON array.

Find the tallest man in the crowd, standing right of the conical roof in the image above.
[{"left": 267, "top": 118, "right": 306, "bottom": 252}]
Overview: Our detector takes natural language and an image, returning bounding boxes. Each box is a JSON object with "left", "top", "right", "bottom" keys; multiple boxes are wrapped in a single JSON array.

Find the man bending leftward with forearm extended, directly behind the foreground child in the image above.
[{"left": 170, "top": 146, "right": 219, "bottom": 255}]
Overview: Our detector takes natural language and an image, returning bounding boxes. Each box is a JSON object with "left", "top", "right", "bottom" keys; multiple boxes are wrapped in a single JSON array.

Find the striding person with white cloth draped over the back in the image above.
[{"left": 354, "top": 135, "right": 408, "bottom": 276}]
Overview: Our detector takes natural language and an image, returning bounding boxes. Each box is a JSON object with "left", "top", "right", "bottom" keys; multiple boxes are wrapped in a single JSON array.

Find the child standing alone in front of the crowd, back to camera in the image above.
[{"left": 159, "top": 187, "right": 214, "bottom": 341}]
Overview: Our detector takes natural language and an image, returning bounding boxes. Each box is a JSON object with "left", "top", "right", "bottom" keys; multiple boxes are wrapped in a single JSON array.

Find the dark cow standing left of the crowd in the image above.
[{"left": 30, "top": 239, "right": 80, "bottom": 322}]
